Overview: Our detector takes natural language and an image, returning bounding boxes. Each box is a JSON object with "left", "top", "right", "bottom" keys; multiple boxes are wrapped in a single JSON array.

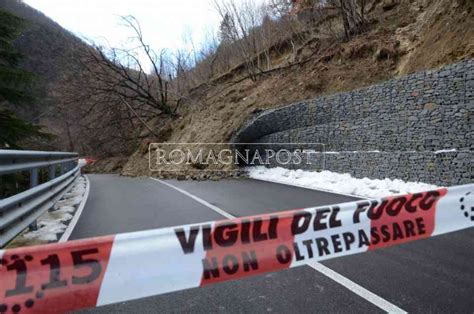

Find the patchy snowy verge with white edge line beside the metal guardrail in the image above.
[{"left": 8, "top": 175, "right": 90, "bottom": 248}]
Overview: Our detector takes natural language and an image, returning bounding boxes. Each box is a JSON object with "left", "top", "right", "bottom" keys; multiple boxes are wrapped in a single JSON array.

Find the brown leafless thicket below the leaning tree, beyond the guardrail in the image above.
[{"left": 53, "top": 66, "right": 146, "bottom": 156}]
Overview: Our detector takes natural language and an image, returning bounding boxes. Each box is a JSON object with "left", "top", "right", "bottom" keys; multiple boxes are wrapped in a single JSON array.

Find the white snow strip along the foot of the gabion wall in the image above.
[{"left": 247, "top": 166, "right": 437, "bottom": 198}]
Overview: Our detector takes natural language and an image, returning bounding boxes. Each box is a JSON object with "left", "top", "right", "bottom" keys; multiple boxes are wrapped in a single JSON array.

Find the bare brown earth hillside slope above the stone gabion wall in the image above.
[{"left": 122, "top": 0, "right": 474, "bottom": 175}]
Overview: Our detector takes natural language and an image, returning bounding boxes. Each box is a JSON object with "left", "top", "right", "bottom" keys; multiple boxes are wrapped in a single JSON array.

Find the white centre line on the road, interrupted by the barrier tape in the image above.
[{"left": 150, "top": 178, "right": 407, "bottom": 313}]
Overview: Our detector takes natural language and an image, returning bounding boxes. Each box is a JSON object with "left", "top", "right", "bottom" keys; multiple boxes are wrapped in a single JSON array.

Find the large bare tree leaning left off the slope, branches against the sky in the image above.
[{"left": 80, "top": 16, "right": 179, "bottom": 116}]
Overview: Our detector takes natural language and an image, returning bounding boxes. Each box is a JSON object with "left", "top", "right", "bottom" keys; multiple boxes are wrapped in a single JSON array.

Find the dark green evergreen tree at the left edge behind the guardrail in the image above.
[{"left": 0, "top": 9, "right": 50, "bottom": 148}]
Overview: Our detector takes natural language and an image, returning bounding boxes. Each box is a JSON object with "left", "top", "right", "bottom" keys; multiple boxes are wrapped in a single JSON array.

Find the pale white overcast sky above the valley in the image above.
[{"left": 24, "top": 0, "right": 226, "bottom": 50}]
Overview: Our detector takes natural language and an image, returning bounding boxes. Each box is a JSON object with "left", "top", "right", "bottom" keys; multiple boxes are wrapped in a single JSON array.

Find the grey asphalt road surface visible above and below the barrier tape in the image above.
[{"left": 71, "top": 175, "right": 474, "bottom": 313}]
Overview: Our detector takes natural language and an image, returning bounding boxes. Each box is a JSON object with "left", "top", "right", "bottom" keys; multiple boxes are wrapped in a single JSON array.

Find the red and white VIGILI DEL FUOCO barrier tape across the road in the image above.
[{"left": 0, "top": 184, "right": 474, "bottom": 313}]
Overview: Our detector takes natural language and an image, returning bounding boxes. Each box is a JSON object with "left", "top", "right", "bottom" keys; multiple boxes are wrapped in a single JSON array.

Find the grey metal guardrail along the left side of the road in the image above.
[{"left": 0, "top": 150, "right": 80, "bottom": 248}]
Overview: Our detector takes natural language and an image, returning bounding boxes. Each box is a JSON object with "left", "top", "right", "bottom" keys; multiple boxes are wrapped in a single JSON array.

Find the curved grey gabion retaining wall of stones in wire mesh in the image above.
[{"left": 233, "top": 60, "right": 474, "bottom": 185}]
